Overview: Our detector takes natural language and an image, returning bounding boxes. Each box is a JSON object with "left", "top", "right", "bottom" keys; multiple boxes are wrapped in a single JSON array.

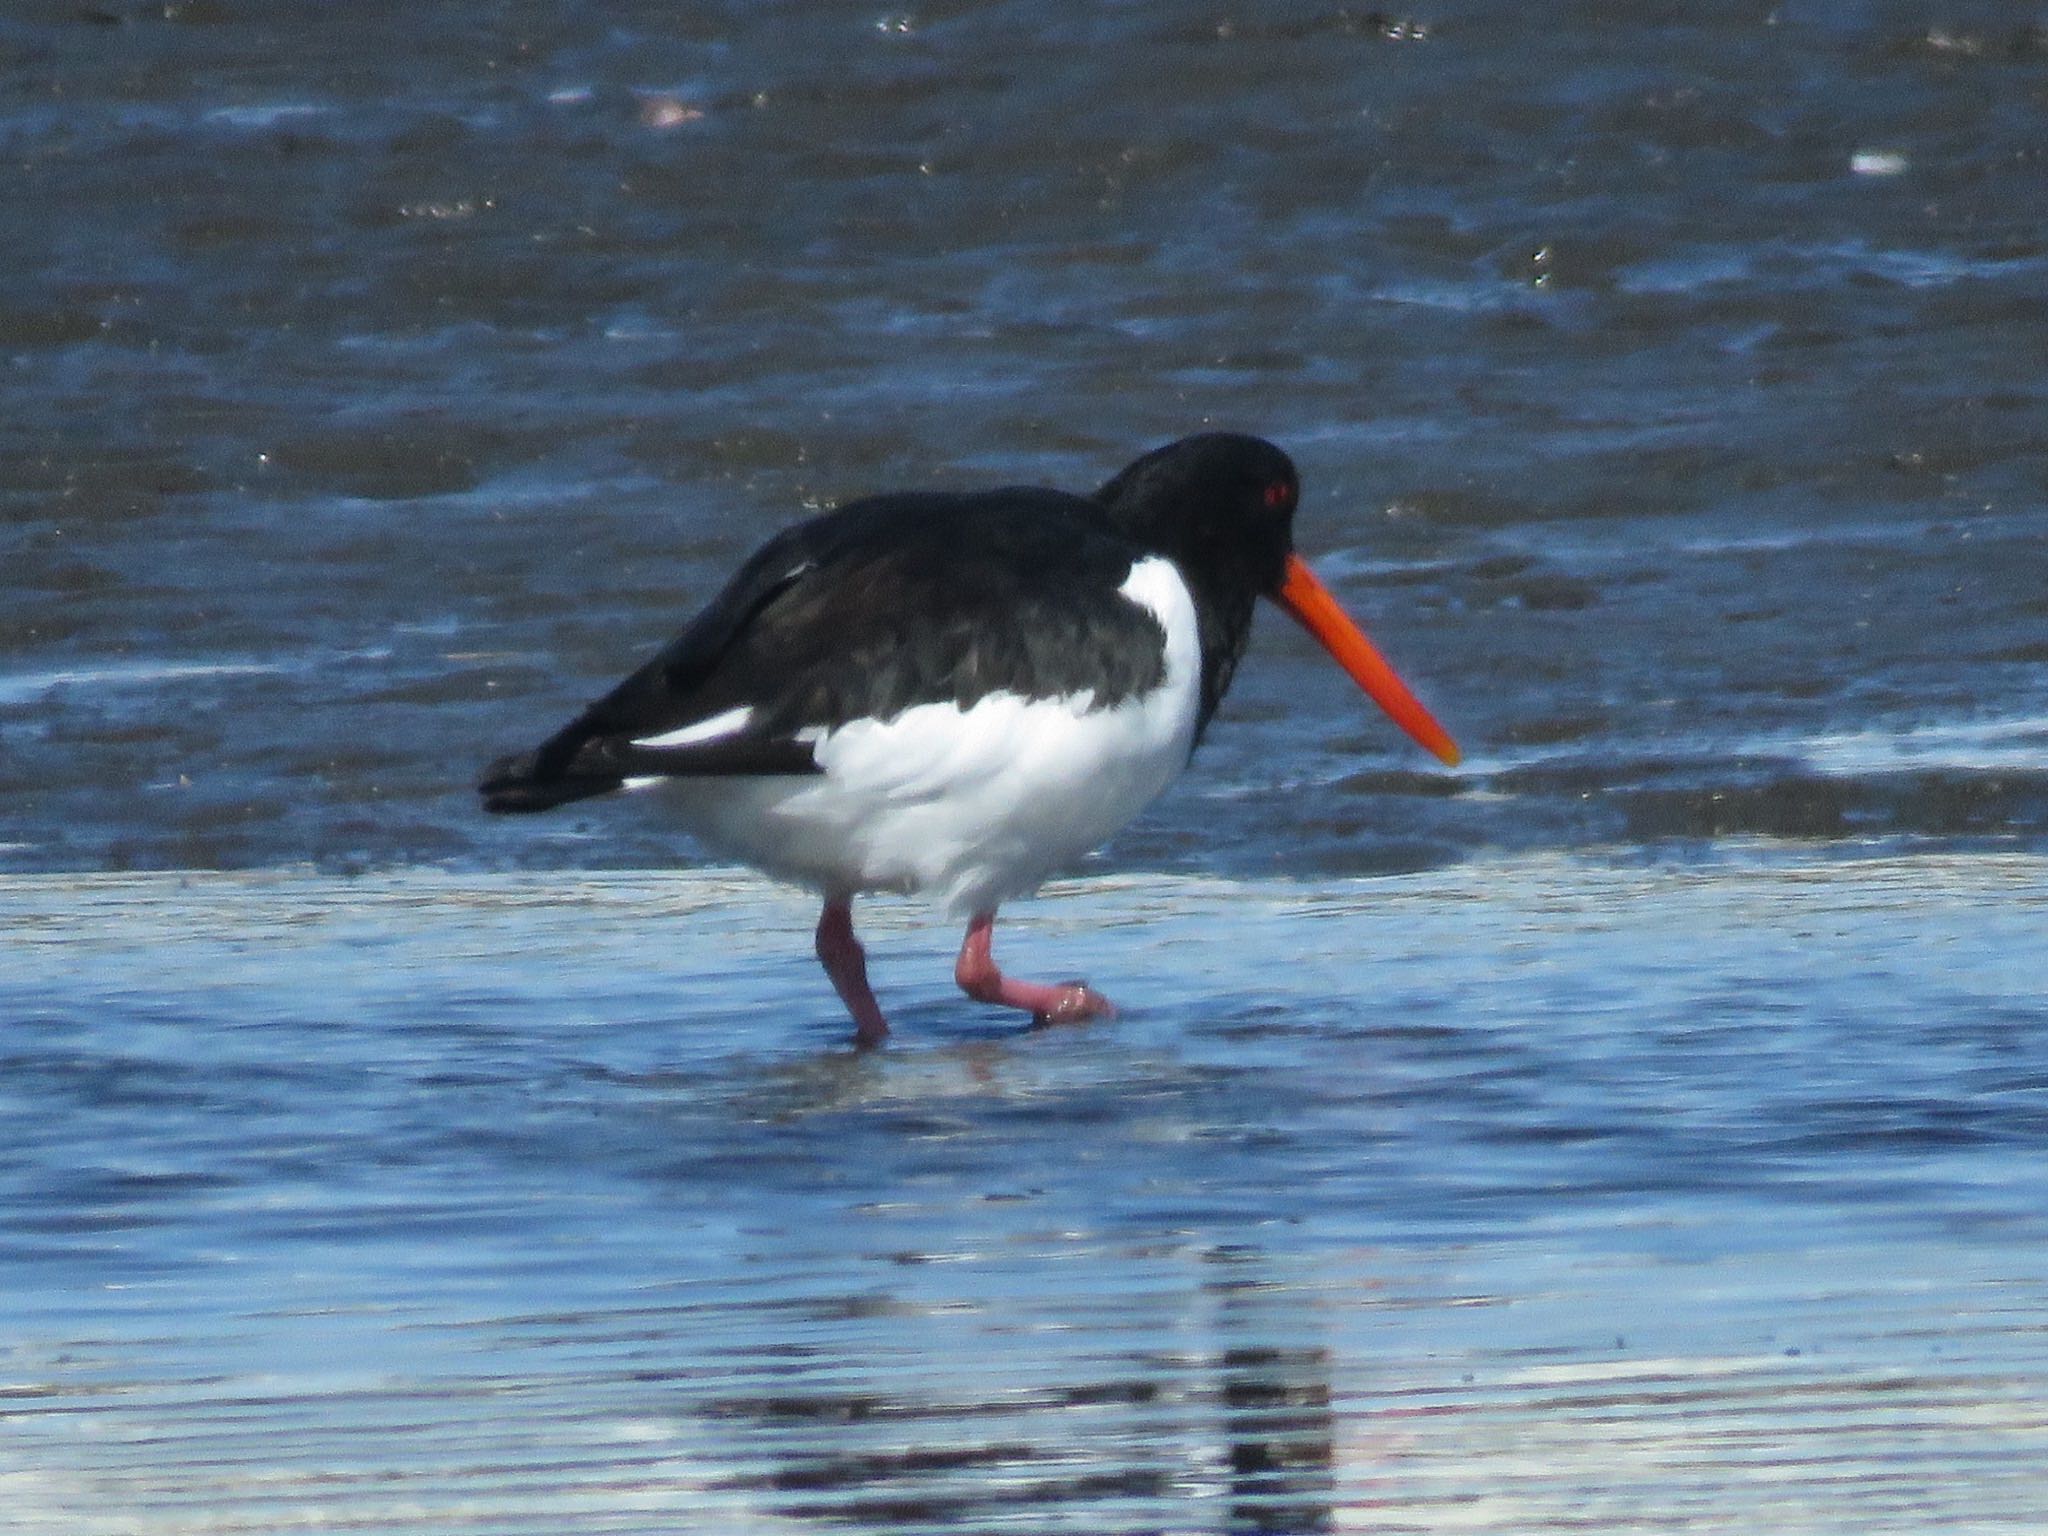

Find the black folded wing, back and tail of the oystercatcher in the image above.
[{"left": 468, "top": 489, "right": 1163, "bottom": 811}]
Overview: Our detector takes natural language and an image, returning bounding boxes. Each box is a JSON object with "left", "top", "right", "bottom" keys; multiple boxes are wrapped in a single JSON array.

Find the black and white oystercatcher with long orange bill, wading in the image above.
[{"left": 479, "top": 432, "right": 1458, "bottom": 1044}]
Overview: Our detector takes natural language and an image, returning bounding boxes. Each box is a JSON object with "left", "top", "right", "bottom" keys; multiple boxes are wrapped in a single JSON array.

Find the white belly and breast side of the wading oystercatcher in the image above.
[{"left": 647, "top": 559, "right": 1200, "bottom": 913}]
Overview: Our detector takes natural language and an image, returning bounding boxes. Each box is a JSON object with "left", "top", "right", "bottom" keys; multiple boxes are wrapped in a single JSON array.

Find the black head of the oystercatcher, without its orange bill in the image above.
[{"left": 1096, "top": 432, "right": 1300, "bottom": 600}]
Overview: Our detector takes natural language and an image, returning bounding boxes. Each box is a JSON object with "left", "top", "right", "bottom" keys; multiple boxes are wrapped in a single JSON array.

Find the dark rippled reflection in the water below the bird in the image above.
[{"left": 698, "top": 1245, "right": 1335, "bottom": 1536}]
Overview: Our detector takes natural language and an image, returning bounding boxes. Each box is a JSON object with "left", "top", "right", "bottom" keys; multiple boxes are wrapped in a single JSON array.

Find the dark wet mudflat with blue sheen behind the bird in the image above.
[{"left": 0, "top": 0, "right": 2048, "bottom": 872}]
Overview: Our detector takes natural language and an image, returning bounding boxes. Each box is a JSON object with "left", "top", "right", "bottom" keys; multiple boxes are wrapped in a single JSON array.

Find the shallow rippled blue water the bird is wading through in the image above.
[{"left": 0, "top": 856, "right": 2048, "bottom": 1532}]
